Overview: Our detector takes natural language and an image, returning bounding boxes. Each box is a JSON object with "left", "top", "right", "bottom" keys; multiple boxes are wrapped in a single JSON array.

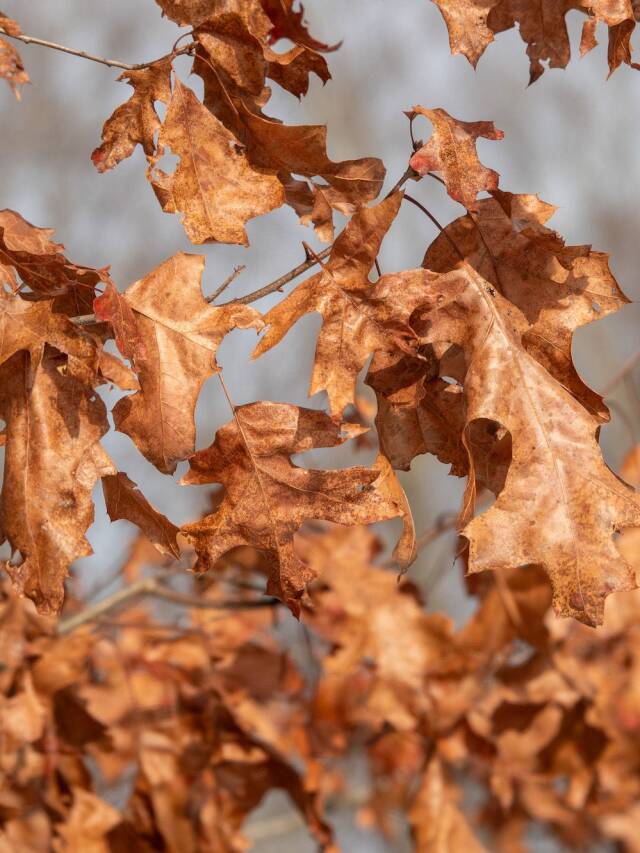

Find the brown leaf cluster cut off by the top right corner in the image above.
[{"left": 434, "top": 0, "right": 640, "bottom": 83}]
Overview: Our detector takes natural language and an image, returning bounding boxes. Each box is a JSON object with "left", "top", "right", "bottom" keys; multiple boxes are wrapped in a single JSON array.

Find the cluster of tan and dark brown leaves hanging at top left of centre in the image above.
[{"left": 92, "top": 0, "right": 385, "bottom": 245}]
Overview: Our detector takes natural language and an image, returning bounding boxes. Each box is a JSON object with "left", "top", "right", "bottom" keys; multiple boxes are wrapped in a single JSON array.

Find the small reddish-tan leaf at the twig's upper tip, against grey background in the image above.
[{"left": 409, "top": 106, "right": 504, "bottom": 210}]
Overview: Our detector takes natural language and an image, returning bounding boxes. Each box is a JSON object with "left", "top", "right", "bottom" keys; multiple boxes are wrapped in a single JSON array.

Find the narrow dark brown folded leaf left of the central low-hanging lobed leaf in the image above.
[{"left": 102, "top": 471, "right": 180, "bottom": 557}]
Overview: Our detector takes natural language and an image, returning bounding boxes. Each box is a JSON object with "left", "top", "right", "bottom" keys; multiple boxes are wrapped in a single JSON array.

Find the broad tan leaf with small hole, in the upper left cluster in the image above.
[{"left": 148, "top": 79, "right": 284, "bottom": 245}]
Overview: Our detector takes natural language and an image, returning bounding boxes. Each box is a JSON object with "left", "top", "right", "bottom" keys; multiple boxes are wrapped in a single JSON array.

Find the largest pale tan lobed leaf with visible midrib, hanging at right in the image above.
[{"left": 420, "top": 264, "right": 640, "bottom": 624}]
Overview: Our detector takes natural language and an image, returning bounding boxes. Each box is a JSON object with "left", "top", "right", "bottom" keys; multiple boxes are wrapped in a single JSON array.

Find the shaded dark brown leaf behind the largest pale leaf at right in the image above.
[{"left": 423, "top": 191, "right": 628, "bottom": 421}]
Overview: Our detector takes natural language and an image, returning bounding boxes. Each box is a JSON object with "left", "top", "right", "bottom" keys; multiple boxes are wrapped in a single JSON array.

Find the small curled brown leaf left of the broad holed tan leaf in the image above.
[{"left": 91, "top": 59, "right": 171, "bottom": 172}]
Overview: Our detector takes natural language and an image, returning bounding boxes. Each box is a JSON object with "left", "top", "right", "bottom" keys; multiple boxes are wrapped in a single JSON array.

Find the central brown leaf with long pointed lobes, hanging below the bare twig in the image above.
[{"left": 254, "top": 193, "right": 412, "bottom": 415}]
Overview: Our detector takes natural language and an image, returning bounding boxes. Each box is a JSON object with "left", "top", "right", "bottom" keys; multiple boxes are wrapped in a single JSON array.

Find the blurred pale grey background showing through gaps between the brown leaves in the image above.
[{"left": 0, "top": 0, "right": 640, "bottom": 853}]
